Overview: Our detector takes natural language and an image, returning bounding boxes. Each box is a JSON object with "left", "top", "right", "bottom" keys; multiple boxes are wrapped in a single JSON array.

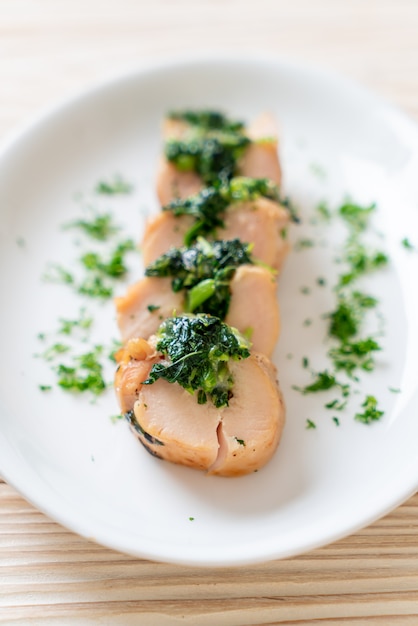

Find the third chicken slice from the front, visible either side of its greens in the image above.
[{"left": 141, "top": 198, "right": 290, "bottom": 270}]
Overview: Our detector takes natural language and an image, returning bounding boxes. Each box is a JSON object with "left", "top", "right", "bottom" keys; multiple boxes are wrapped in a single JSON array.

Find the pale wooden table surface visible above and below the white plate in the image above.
[{"left": 0, "top": 0, "right": 418, "bottom": 626}]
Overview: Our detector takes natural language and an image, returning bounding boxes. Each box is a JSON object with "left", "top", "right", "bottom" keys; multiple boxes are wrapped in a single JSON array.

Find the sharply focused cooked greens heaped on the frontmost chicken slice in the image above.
[{"left": 144, "top": 314, "right": 250, "bottom": 407}]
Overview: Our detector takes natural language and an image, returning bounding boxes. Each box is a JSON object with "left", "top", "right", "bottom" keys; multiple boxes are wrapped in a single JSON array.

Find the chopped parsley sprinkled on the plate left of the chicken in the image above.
[{"left": 38, "top": 177, "right": 135, "bottom": 396}]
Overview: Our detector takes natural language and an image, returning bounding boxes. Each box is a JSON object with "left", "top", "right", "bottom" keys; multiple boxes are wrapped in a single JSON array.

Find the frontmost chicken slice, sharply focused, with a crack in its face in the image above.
[{"left": 125, "top": 354, "right": 285, "bottom": 476}]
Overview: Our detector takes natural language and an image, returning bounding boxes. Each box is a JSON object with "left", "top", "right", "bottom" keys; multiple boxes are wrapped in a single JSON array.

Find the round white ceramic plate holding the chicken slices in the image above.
[{"left": 0, "top": 58, "right": 418, "bottom": 565}]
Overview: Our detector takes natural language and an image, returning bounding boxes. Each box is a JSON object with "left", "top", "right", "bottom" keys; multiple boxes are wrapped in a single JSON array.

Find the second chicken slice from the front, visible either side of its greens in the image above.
[{"left": 115, "top": 265, "right": 280, "bottom": 356}]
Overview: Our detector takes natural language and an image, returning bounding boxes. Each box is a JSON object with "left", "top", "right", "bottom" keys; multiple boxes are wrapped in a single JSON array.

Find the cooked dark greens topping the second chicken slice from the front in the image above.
[{"left": 145, "top": 238, "right": 253, "bottom": 319}]
